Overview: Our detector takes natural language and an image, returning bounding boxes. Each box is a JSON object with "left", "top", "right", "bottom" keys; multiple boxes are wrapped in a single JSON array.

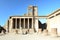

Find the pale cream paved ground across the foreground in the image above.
[{"left": 0, "top": 33, "right": 60, "bottom": 40}]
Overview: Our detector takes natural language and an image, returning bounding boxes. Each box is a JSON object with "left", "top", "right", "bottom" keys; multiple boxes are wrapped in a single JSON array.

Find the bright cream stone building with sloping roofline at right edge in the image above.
[{"left": 47, "top": 9, "right": 60, "bottom": 35}]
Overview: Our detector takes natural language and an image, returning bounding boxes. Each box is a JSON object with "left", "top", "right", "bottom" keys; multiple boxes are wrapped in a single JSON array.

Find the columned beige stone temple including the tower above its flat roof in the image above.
[{"left": 4, "top": 6, "right": 47, "bottom": 33}]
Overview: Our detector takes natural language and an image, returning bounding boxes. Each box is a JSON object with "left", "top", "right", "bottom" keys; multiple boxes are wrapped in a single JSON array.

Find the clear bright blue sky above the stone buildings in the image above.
[{"left": 0, "top": 0, "right": 60, "bottom": 25}]
